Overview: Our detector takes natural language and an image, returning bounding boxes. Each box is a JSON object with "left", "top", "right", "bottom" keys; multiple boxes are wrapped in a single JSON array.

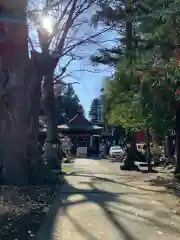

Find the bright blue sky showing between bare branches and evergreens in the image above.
[{"left": 28, "top": 0, "right": 116, "bottom": 115}]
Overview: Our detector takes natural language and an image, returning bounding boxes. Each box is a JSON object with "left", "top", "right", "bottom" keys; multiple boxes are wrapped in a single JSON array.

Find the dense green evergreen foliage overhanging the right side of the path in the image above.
[{"left": 91, "top": 0, "right": 180, "bottom": 172}]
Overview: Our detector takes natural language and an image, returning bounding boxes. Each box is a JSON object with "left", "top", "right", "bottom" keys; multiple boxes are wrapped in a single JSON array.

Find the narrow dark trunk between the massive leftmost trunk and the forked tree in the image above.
[{"left": 27, "top": 60, "right": 42, "bottom": 183}]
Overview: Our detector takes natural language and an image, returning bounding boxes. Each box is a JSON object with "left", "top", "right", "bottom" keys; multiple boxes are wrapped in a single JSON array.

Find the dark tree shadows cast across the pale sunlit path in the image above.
[{"left": 36, "top": 169, "right": 180, "bottom": 240}]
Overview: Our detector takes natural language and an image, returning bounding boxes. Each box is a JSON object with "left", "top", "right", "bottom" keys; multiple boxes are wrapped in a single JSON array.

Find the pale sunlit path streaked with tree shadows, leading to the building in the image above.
[{"left": 36, "top": 159, "right": 180, "bottom": 240}]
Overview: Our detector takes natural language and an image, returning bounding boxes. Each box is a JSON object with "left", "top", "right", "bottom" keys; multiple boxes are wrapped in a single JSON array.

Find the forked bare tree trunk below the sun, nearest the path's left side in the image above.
[{"left": 38, "top": 0, "right": 78, "bottom": 171}]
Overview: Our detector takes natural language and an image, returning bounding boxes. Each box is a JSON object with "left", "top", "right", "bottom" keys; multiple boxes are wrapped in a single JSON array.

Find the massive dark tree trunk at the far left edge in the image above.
[{"left": 0, "top": 0, "right": 28, "bottom": 184}]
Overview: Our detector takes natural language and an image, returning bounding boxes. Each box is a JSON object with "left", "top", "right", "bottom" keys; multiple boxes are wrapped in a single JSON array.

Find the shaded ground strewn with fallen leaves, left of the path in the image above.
[{"left": 0, "top": 186, "right": 57, "bottom": 240}]
